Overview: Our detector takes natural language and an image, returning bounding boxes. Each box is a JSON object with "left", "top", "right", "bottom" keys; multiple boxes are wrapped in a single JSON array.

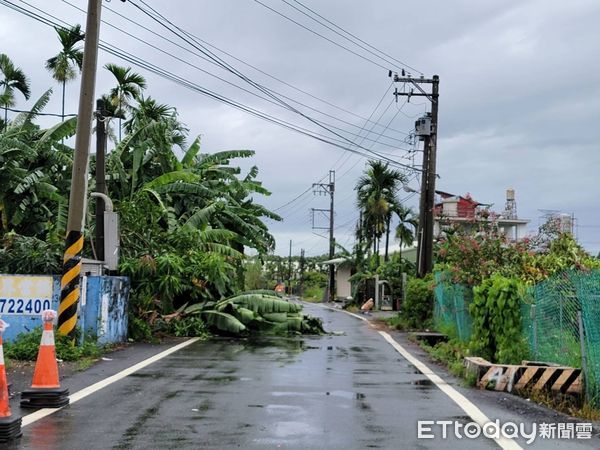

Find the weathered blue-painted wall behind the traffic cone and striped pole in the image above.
[{"left": 0, "top": 275, "right": 129, "bottom": 344}]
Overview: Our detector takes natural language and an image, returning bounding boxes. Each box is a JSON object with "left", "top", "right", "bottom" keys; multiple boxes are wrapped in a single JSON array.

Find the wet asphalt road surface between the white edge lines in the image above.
[{"left": 11, "top": 306, "right": 597, "bottom": 450}]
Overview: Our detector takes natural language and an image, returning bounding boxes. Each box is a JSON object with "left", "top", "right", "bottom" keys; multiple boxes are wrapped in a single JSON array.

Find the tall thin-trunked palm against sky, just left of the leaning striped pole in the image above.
[{"left": 46, "top": 25, "right": 85, "bottom": 122}]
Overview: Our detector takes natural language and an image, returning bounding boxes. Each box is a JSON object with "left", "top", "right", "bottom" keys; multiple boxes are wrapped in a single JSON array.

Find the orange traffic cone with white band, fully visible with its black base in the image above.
[{"left": 21, "top": 310, "right": 69, "bottom": 408}]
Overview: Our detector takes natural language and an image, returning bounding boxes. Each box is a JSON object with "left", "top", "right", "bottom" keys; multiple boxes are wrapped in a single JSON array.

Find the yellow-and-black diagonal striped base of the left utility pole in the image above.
[{"left": 58, "top": 231, "right": 83, "bottom": 338}]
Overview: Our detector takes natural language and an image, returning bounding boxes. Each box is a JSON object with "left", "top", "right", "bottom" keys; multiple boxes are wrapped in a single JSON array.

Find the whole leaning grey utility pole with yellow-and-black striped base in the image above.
[{"left": 58, "top": 0, "right": 102, "bottom": 338}]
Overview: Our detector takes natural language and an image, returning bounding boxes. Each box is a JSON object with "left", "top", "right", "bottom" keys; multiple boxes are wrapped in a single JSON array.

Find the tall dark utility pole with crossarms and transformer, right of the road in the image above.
[{"left": 394, "top": 73, "right": 440, "bottom": 278}]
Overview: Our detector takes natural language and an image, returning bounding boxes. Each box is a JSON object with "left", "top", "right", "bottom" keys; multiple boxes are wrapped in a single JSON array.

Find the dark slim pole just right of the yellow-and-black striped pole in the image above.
[{"left": 96, "top": 99, "right": 107, "bottom": 261}]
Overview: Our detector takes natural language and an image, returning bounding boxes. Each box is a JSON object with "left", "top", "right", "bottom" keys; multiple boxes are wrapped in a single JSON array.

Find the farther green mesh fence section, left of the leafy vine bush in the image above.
[{"left": 433, "top": 273, "right": 473, "bottom": 342}]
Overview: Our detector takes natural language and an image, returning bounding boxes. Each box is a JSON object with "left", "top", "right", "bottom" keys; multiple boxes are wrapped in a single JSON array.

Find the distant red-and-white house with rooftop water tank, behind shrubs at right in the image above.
[{"left": 433, "top": 189, "right": 529, "bottom": 241}]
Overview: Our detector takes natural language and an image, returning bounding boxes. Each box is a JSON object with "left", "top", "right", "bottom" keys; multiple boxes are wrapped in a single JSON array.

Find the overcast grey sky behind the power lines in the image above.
[{"left": 0, "top": 0, "right": 600, "bottom": 255}]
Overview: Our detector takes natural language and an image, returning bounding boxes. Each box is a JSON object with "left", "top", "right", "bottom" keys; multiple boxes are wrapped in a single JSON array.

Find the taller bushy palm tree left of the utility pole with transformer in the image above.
[{"left": 355, "top": 161, "right": 406, "bottom": 268}]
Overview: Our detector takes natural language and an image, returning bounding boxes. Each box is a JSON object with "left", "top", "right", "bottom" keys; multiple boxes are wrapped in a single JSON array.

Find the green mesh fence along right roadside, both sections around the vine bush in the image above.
[{"left": 434, "top": 270, "right": 600, "bottom": 407}]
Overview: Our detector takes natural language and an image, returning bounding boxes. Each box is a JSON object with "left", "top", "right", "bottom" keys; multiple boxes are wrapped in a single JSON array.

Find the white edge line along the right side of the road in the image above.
[{"left": 318, "top": 305, "right": 523, "bottom": 450}]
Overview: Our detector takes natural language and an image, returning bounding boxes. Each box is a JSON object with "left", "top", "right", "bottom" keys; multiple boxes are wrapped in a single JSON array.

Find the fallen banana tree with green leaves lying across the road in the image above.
[{"left": 183, "top": 290, "right": 325, "bottom": 336}]
